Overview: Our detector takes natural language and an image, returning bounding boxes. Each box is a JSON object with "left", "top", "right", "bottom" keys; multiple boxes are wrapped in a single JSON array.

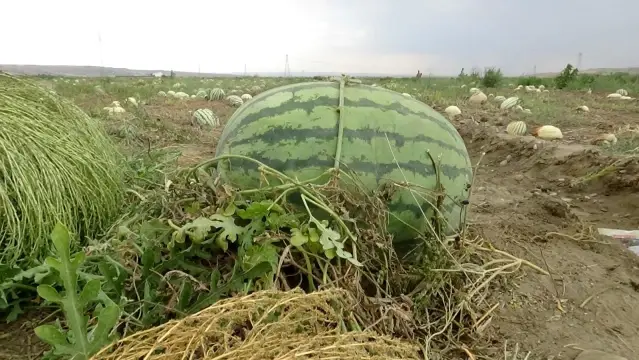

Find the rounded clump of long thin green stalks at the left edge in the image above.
[{"left": 0, "top": 73, "right": 124, "bottom": 266}]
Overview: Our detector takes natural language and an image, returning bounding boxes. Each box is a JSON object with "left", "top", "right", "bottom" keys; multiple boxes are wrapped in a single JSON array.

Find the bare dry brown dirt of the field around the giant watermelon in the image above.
[{"left": 0, "top": 78, "right": 639, "bottom": 360}]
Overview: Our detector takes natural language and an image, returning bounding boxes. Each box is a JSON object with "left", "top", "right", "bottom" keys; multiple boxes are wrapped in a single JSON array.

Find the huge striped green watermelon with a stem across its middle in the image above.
[{"left": 216, "top": 82, "right": 472, "bottom": 253}]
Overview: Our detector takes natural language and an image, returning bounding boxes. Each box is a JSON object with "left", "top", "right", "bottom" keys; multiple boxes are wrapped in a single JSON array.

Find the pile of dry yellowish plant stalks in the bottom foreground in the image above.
[{"left": 93, "top": 290, "right": 423, "bottom": 360}]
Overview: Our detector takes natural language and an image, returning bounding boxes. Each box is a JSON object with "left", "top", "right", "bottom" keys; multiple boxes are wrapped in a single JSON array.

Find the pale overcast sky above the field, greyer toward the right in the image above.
[{"left": 0, "top": 0, "right": 639, "bottom": 75}]
